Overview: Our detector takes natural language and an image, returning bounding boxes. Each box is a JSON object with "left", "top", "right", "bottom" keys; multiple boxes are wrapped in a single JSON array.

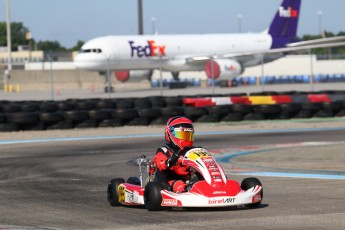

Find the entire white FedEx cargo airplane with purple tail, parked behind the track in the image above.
[{"left": 74, "top": 0, "right": 345, "bottom": 81}]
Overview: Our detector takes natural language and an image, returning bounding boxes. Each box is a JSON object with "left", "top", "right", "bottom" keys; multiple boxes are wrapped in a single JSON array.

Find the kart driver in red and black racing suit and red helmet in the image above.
[{"left": 153, "top": 116, "right": 194, "bottom": 193}]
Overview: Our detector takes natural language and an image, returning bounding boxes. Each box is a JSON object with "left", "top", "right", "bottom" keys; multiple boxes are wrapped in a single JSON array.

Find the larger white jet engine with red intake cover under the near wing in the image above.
[{"left": 204, "top": 59, "right": 244, "bottom": 80}]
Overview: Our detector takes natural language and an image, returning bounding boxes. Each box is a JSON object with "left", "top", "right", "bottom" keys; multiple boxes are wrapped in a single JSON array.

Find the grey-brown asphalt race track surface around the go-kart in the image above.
[{"left": 0, "top": 127, "right": 345, "bottom": 229}]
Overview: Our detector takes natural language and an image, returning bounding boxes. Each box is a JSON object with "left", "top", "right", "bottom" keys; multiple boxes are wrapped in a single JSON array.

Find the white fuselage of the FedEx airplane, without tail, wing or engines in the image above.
[{"left": 75, "top": 33, "right": 272, "bottom": 71}]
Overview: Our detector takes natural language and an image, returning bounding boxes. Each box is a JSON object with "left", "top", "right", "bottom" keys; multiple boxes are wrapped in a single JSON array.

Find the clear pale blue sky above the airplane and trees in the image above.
[{"left": 0, "top": 0, "right": 345, "bottom": 48}]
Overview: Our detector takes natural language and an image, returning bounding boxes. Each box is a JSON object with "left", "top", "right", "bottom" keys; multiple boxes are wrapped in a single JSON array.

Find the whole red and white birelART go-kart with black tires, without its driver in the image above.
[{"left": 107, "top": 148, "right": 263, "bottom": 211}]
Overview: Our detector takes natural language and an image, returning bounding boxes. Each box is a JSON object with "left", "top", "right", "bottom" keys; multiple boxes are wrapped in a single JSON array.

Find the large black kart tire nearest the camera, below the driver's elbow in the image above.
[{"left": 144, "top": 182, "right": 163, "bottom": 211}]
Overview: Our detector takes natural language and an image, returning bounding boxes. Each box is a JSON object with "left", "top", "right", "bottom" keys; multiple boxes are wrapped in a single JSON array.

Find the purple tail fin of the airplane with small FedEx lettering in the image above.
[{"left": 268, "top": 0, "right": 301, "bottom": 48}]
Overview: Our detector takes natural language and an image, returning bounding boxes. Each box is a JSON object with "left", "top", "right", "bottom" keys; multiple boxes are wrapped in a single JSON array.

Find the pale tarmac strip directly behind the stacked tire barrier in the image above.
[{"left": 0, "top": 82, "right": 345, "bottom": 101}]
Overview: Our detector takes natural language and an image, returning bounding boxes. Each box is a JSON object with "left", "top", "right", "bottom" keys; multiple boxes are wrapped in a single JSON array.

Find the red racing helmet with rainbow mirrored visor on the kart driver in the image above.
[{"left": 165, "top": 116, "right": 194, "bottom": 150}]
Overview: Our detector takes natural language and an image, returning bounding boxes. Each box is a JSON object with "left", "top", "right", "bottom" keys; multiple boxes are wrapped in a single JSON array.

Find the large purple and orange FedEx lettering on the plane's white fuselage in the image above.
[{"left": 128, "top": 40, "right": 165, "bottom": 57}]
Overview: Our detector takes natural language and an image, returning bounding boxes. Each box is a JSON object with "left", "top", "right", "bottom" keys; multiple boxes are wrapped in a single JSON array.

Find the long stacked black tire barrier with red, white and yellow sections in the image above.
[{"left": 0, "top": 91, "right": 345, "bottom": 132}]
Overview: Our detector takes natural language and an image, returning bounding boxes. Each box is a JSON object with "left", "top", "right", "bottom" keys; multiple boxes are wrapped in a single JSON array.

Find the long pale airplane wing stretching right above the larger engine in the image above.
[{"left": 186, "top": 36, "right": 345, "bottom": 64}]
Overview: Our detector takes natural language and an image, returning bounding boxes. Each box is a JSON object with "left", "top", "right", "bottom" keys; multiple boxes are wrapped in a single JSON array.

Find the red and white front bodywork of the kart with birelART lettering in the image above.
[{"left": 161, "top": 148, "right": 262, "bottom": 207}]
